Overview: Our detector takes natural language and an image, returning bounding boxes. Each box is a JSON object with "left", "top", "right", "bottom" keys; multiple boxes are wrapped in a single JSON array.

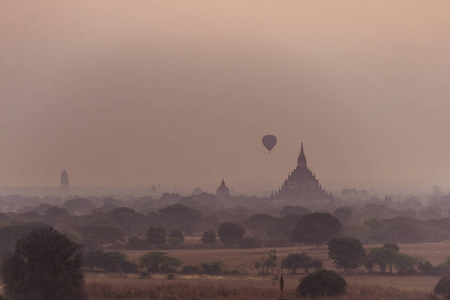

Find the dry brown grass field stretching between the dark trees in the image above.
[{"left": 81, "top": 243, "right": 450, "bottom": 300}]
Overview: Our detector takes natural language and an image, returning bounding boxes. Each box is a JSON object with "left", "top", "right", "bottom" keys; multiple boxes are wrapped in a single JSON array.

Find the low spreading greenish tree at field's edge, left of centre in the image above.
[{"left": 138, "top": 251, "right": 182, "bottom": 273}]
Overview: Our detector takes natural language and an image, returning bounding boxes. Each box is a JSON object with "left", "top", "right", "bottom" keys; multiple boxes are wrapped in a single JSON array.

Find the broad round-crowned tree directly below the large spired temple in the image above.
[{"left": 291, "top": 212, "right": 342, "bottom": 247}]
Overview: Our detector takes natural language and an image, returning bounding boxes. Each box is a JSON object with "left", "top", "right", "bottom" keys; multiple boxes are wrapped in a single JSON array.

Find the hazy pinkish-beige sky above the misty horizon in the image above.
[{"left": 0, "top": 0, "right": 450, "bottom": 190}]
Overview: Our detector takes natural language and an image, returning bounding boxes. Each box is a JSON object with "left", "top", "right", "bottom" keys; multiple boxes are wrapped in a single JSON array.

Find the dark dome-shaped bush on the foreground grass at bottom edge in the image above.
[{"left": 297, "top": 270, "right": 347, "bottom": 298}]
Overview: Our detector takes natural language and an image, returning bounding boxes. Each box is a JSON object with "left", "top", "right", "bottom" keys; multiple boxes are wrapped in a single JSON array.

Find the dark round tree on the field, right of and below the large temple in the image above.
[{"left": 328, "top": 237, "right": 366, "bottom": 272}]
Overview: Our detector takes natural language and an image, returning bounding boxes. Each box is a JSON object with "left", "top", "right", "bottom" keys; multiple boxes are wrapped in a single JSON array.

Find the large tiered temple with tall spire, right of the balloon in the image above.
[{"left": 273, "top": 142, "right": 334, "bottom": 201}]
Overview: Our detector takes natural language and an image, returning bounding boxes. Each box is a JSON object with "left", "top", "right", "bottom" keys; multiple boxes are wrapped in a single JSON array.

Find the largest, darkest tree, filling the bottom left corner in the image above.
[{"left": 1, "top": 226, "right": 86, "bottom": 300}]
